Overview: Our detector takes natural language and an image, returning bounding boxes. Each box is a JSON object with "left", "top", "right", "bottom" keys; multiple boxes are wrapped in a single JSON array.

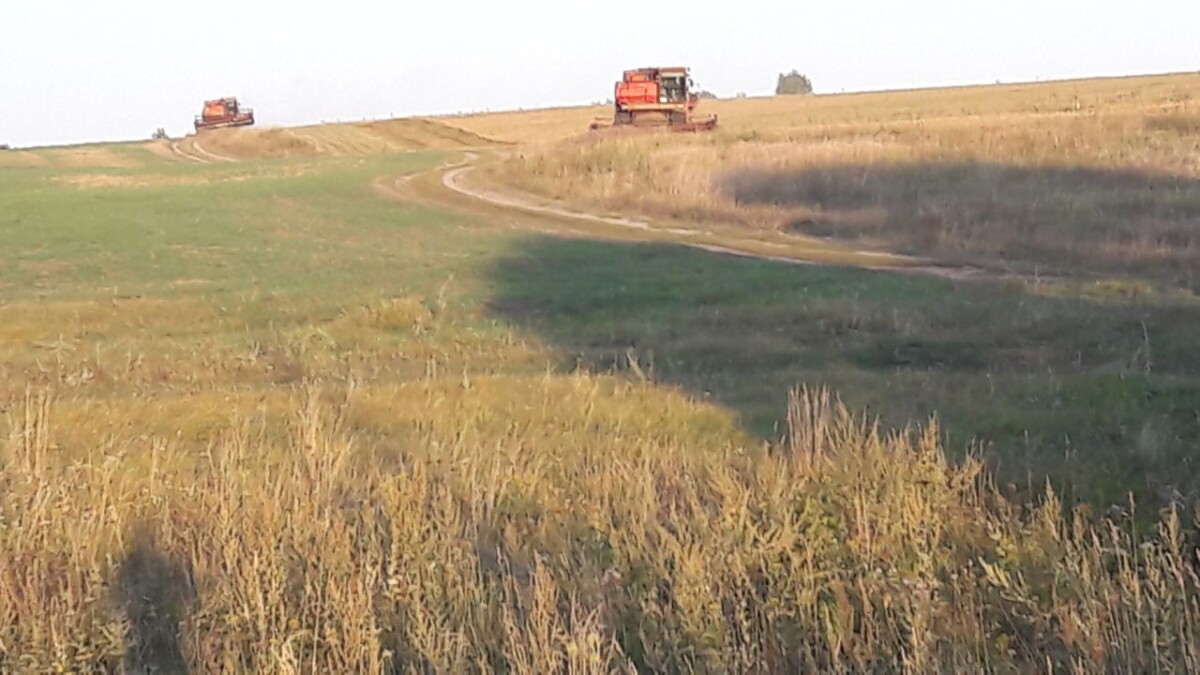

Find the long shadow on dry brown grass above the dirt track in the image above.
[{"left": 719, "top": 162, "right": 1200, "bottom": 284}]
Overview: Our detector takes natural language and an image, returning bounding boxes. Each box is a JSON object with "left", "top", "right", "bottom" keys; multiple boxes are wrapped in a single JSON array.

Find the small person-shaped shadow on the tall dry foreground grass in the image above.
[{"left": 114, "top": 526, "right": 193, "bottom": 674}]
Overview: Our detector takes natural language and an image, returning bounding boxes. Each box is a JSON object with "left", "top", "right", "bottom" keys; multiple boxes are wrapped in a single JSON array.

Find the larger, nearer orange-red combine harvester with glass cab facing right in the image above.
[{"left": 592, "top": 67, "right": 716, "bottom": 131}]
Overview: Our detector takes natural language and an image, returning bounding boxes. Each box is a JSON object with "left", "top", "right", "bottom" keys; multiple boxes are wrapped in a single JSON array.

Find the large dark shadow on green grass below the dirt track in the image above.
[{"left": 491, "top": 237, "right": 1200, "bottom": 501}]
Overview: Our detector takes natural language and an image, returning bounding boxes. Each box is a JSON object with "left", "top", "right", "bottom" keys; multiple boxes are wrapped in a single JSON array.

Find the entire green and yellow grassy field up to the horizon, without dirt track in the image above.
[{"left": 0, "top": 76, "right": 1200, "bottom": 673}]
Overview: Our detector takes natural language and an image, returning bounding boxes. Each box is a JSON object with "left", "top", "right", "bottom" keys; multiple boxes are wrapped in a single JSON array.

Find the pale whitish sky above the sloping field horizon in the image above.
[{"left": 0, "top": 0, "right": 1200, "bottom": 147}]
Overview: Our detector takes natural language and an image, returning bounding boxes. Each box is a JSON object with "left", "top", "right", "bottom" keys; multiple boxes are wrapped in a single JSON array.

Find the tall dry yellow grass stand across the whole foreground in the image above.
[{"left": 9, "top": 376, "right": 1200, "bottom": 673}]
